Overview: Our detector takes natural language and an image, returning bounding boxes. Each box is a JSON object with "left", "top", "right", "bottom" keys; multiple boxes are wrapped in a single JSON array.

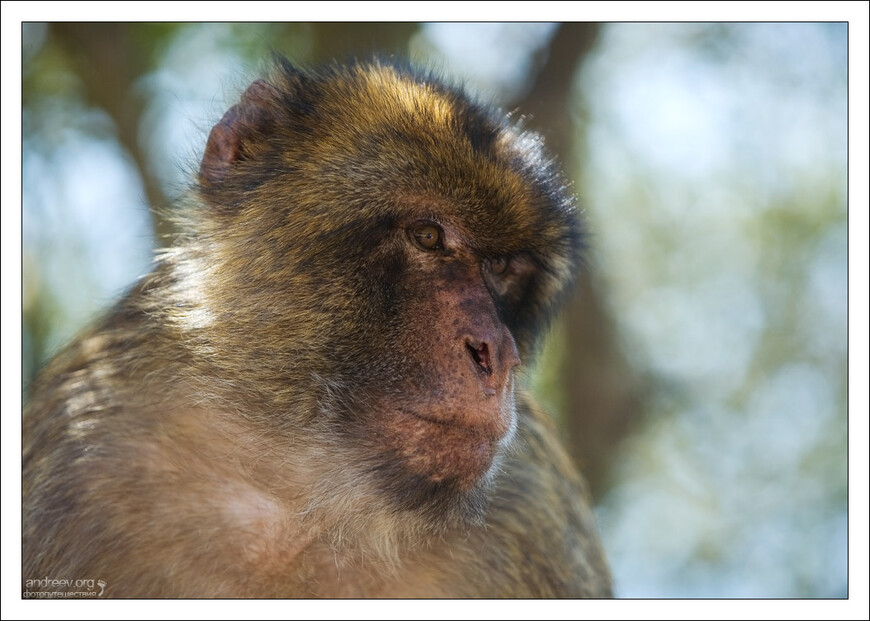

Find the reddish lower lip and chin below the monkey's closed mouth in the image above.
[{"left": 387, "top": 415, "right": 500, "bottom": 490}]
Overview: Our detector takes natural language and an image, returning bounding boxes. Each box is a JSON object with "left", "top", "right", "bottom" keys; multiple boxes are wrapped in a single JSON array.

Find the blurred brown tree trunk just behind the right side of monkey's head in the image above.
[{"left": 514, "top": 23, "right": 644, "bottom": 497}]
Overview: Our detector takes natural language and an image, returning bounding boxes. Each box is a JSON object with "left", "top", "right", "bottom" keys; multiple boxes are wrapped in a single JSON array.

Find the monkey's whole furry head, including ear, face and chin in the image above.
[{"left": 187, "top": 60, "right": 580, "bottom": 516}]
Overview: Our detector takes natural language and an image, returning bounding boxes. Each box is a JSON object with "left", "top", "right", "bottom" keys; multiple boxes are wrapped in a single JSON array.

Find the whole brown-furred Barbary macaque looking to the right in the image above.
[{"left": 23, "top": 59, "right": 610, "bottom": 598}]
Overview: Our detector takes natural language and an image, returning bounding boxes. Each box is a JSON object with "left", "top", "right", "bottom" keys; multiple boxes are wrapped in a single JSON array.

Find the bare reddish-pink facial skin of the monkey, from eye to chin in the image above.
[{"left": 364, "top": 220, "right": 520, "bottom": 490}]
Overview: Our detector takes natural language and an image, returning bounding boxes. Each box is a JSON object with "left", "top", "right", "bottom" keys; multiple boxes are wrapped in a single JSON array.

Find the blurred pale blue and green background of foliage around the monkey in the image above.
[{"left": 22, "top": 23, "right": 852, "bottom": 598}]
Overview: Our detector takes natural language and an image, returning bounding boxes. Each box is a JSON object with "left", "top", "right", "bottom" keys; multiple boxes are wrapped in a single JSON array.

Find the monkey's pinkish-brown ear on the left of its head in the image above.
[{"left": 199, "top": 80, "right": 279, "bottom": 185}]
